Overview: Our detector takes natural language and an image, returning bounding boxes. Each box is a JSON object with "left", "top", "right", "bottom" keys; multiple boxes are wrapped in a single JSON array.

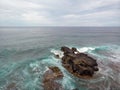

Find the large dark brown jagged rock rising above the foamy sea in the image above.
[{"left": 61, "top": 46, "right": 98, "bottom": 79}]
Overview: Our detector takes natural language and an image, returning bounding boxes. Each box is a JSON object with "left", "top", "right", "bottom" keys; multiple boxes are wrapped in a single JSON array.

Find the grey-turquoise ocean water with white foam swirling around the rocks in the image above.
[{"left": 0, "top": 27, "right": 120, "bottom": 90}]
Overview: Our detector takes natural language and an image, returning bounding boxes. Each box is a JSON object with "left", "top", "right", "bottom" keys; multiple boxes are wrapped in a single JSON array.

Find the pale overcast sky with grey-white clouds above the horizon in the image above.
[{"left": 0, "top": 0, "right": 120, "bottom": 26}]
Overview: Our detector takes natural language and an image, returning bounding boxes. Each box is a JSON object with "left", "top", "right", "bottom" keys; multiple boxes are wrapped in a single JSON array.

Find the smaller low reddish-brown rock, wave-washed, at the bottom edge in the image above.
[{"left": 43, "top": 67, "right": 63, "bottom": 90}]
